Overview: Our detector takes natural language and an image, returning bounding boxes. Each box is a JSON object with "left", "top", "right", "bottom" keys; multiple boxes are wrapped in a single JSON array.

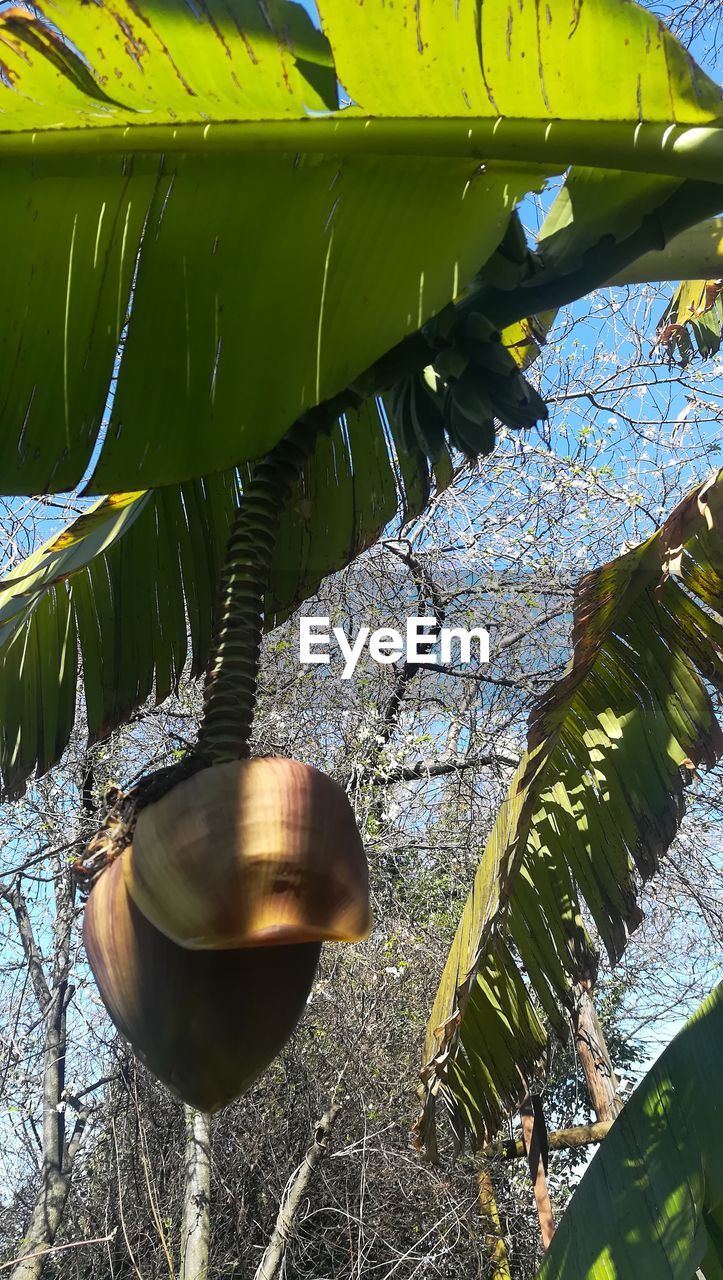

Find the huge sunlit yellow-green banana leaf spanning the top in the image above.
[{"left": 0, "top": 0, "right": 723, "bottom": 493}]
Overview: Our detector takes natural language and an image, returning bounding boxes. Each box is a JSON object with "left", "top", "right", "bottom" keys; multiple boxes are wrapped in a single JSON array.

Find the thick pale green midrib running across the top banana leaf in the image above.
[{"left": 0, "top": 110, "right": 723, "bottom": 182}]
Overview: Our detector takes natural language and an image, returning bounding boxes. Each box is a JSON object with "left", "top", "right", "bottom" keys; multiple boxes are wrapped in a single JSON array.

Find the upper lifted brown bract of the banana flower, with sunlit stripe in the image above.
[{"left": 124, "top": 758, "right": 370, "bottom": 948}]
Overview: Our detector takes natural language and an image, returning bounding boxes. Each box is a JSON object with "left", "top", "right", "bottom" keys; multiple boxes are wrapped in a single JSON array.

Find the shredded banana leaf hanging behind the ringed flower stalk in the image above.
[{"left": 0, "top": 401, "right": 450, "bottom": 794}]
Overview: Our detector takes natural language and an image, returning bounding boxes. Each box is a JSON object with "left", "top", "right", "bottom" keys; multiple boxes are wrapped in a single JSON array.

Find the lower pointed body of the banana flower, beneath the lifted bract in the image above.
[{"left": 83, "top": 851, "right": 321, "bottom": 1111}]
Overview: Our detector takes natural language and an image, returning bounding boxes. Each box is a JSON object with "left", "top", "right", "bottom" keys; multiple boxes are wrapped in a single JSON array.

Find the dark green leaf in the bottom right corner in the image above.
[{"left": 537, "top": 984, "right": 723, "bottom": 1280}]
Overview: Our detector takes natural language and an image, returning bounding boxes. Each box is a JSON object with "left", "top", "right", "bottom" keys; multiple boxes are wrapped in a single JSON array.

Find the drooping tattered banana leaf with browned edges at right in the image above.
[{"left": 418, "top": 472, "right": 723, "bottom": 1149}]
